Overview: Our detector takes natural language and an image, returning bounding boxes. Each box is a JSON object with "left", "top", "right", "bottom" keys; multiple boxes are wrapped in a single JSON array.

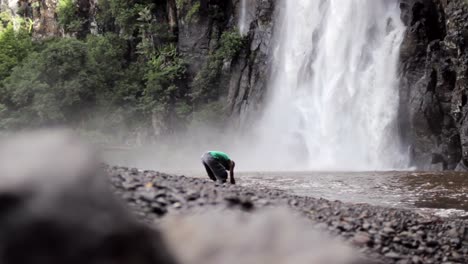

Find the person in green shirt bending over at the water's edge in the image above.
[{"left": 201, "top": 151, "right": 236, "bottom": 184}]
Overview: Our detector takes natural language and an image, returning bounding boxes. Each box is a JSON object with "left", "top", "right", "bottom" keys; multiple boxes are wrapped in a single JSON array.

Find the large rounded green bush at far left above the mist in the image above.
[{"left": 4, "top": 39, "right": 92, "bottom": 127}]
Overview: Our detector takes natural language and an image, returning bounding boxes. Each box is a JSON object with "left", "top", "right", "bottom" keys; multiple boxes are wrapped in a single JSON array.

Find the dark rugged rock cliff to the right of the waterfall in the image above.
[{"left": 400, "top": 0, "right": 468, "bottom": 170}]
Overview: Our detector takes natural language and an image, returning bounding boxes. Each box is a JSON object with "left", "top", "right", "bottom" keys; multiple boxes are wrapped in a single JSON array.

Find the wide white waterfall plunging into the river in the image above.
[{"left": 250, "top": 0, "right": 407, "bottom": 170}]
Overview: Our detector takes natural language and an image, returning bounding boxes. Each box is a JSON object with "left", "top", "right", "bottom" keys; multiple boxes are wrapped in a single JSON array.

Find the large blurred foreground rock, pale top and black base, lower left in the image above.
[{"left": 0, "top": 131, "right": 174, "bottom": 264}]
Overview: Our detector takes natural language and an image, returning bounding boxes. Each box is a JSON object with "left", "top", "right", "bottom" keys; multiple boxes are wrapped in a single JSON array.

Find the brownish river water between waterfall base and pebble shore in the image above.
[{"left": 161, "top": 171, "right": 468, "bottom": 218}]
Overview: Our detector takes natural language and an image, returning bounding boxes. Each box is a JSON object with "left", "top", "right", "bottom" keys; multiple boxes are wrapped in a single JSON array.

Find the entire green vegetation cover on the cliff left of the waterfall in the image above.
[{"left": 0, "top": 0, "right": 249, "bottom": 141}]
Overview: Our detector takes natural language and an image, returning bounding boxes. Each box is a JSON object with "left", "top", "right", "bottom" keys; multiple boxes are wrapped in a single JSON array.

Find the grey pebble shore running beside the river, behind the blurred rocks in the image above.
[{"left": 106, "top": 167, "right": 468, "bottom": 264}]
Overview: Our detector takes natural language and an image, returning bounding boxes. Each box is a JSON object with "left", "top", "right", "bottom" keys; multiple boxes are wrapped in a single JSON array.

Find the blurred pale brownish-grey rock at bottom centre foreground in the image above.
[{"left": 162, "top": 209, "right": 371, "bottom": 264}]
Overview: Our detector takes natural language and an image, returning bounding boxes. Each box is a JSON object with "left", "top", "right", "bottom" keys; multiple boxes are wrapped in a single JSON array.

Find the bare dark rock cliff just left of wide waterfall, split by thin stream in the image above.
[{"left": 178, "top": 0, "right": 275, "bottom": 127}]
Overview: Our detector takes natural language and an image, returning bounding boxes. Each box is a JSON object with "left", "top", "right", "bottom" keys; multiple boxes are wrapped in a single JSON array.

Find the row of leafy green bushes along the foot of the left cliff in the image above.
[{"left": 1, "top": 34, "right": 185, "bottom": 132}]
